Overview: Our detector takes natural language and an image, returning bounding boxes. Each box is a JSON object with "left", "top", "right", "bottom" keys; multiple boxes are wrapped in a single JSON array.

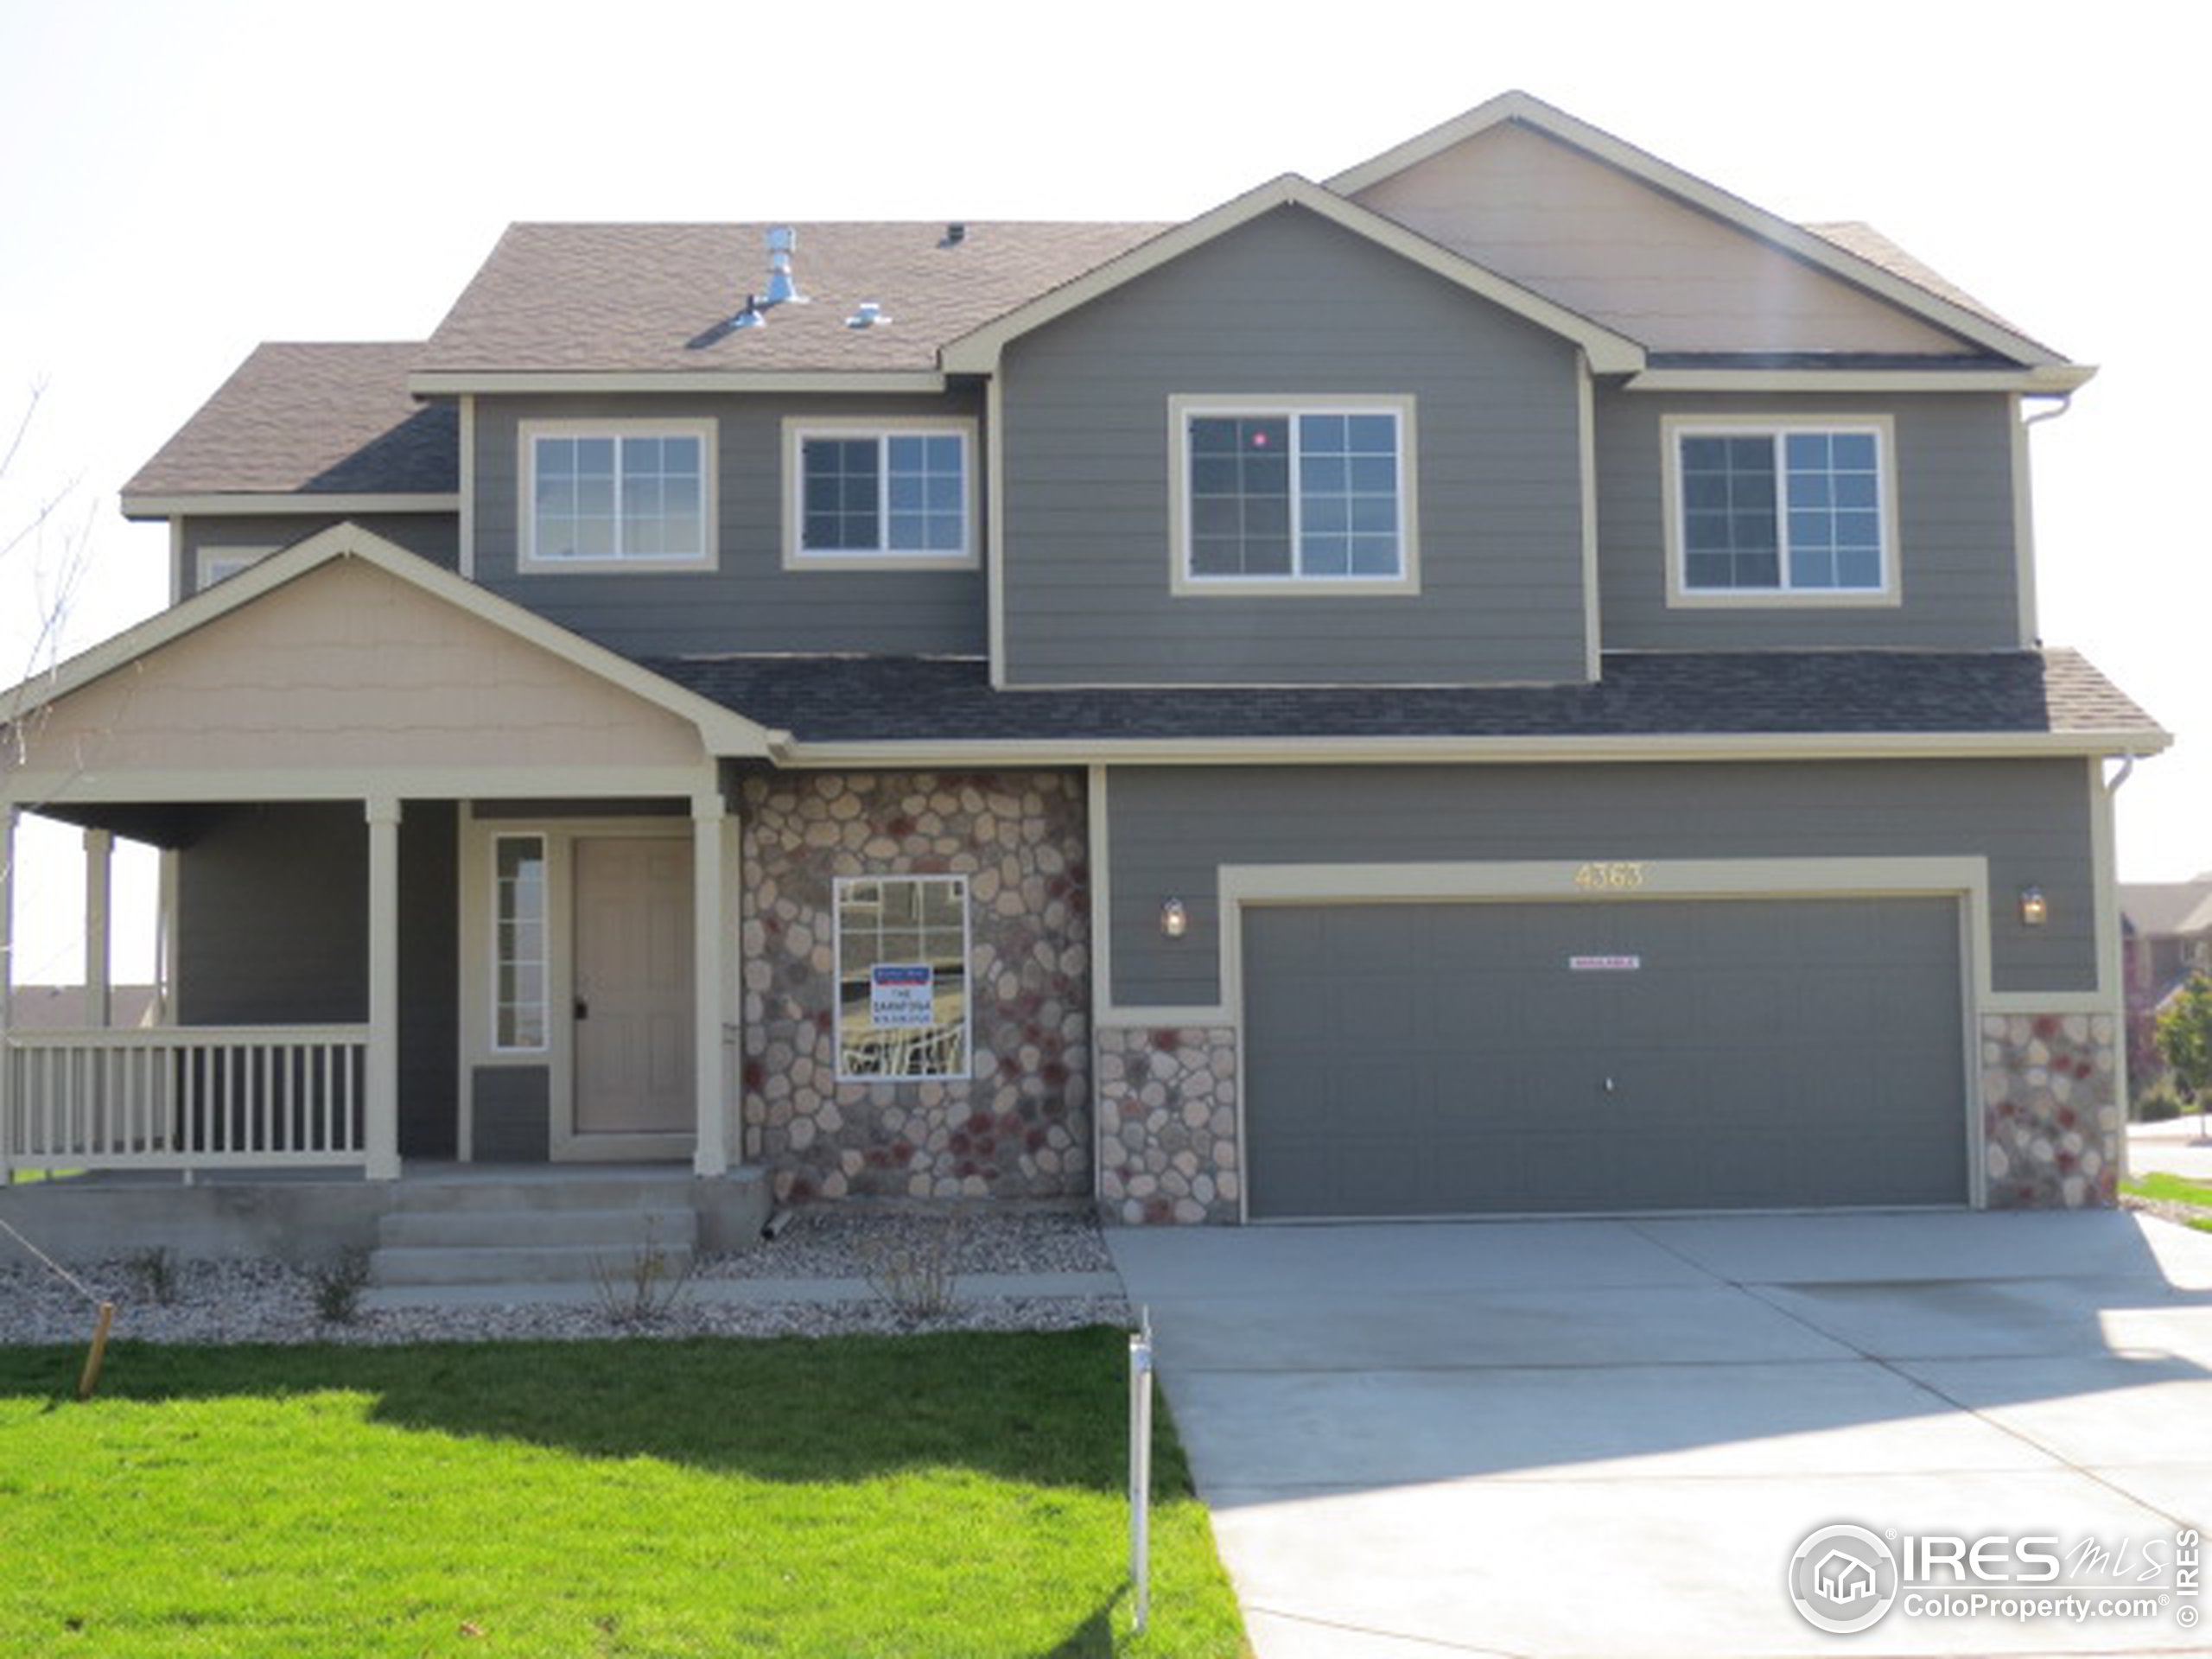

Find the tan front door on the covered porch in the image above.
[{"left": 575, "top": 836, "right": 695, "bottom": 1135}]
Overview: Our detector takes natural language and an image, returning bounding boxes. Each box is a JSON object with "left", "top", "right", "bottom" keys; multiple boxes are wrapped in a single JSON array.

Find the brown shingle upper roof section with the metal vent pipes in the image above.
[{"left": 418, "top": 221, "right": 1168, "bottom": 374}]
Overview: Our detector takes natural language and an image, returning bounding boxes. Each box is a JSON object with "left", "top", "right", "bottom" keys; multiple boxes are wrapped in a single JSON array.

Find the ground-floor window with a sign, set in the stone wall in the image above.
[{"left": 834, "top": 876, "right": 969, "bottom": 1082}]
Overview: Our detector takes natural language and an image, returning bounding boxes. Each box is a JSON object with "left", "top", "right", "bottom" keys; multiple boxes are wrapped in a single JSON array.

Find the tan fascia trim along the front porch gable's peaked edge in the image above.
[{"left": 0, "top": 524, "right": 790, "bottom": 759}]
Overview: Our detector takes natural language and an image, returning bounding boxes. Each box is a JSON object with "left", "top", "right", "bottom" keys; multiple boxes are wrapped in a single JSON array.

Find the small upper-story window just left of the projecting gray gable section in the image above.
[{"left": 783, "top": 420, "right": 976, "bottom": 570}]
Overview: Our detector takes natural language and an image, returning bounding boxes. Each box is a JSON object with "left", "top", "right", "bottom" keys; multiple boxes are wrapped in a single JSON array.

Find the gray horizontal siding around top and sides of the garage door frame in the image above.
[{"left": 1106, "top": 761, "right": 2097, "bottom": 1007}]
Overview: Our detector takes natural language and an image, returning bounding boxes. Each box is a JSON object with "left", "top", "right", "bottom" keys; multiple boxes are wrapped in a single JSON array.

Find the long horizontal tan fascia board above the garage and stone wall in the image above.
[{"left": 777, "top": 728, "right": 2174, "bottom": 772}]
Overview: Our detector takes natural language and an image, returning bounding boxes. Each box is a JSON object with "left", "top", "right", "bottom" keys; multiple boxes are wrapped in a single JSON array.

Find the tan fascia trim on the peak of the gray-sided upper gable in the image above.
[{"left": 938, "top": 173, "right": 1643, "bottom": 374}]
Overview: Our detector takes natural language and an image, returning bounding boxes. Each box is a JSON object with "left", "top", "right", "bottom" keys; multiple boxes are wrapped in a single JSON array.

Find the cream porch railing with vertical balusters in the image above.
[{"left": 0, "top": 1027, "right": 370, "bottom": 1170}]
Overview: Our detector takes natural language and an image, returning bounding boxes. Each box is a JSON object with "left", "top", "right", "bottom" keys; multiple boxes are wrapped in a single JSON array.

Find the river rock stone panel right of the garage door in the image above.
[{"left": 1982, "top": 1013, "right": 2126, "bottom": 1210}]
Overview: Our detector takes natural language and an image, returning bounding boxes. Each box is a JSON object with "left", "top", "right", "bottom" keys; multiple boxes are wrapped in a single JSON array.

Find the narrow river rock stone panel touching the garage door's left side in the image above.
[{"left": 1097, "top": 1027, "right": 1243, "bottom": 1225}]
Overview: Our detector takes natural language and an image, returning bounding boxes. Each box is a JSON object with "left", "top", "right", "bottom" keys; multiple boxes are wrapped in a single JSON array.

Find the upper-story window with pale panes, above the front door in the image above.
[{"left": 520, "top": 420, "right": 715, "bottom": 570}]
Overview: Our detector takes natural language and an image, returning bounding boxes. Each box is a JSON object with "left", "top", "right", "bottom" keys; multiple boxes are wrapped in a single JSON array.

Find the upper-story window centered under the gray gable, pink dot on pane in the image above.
[{"left": 1168, "top": 398, "right": 1415, "bottom": 593}]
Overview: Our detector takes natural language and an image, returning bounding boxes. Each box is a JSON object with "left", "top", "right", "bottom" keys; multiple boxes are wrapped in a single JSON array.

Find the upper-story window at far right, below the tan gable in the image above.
[{"left": 1663, "top": 418, "right": 1897, "bottom": 606}]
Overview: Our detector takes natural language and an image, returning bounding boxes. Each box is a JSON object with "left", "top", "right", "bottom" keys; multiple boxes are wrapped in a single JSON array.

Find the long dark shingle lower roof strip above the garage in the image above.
[{"left": 646, "top": 651, "right": 2159, "bottom": 743}]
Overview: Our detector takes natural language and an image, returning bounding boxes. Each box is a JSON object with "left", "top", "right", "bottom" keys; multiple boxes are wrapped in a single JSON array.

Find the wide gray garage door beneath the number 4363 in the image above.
[{"left": 1245, "top": 898, "right": 1968, "bottom": 1217}]
